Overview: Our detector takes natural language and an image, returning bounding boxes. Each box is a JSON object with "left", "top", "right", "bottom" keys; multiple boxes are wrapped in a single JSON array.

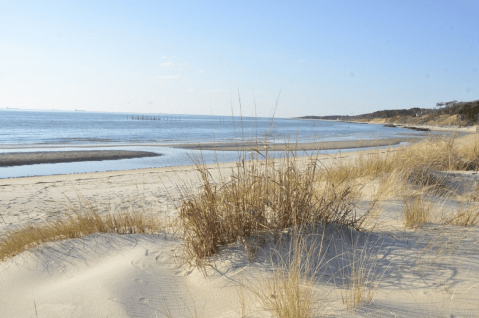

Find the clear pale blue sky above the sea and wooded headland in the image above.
[{"left": 0, "top": 0, "right": 479, "bottom": 118}]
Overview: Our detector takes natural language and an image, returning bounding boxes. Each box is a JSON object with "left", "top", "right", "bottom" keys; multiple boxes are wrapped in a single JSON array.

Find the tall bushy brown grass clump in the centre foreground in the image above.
[{"left": 178, "top": 153, "right": 367, "bottom": 265}]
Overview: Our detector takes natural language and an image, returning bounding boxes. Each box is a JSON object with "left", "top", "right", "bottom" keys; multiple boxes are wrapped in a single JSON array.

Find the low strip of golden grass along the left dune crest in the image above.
[{"left": 0, "top": 194, "right": 162, "bottom": 261}]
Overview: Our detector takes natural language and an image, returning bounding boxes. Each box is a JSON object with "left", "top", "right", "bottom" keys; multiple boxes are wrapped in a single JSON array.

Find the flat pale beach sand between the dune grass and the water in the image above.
[{"left": 0, "top": 148, "right": 372, "bottom": 233}]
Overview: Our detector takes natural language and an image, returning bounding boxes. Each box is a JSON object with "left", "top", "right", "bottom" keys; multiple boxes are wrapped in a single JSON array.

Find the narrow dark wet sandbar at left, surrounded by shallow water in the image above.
[{"left": 0, "top": 150, "right": 161, "bottom": 167}]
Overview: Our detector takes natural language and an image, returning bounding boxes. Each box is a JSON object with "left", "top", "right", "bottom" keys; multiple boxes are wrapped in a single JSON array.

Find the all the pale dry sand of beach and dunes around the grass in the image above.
[{"left": 0, "top": 136, "right": 479, "bottom": 317}]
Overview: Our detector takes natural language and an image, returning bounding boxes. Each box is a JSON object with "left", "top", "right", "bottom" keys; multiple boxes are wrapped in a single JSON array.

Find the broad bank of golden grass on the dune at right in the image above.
[{"left": 322, "top": 135, "right": 479, "bottom": 201}]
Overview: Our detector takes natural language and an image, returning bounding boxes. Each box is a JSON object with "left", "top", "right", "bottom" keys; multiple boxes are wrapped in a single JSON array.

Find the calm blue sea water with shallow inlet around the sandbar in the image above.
[{"left": 0, "top": 109, "right": 426, "bottom": 178}]
